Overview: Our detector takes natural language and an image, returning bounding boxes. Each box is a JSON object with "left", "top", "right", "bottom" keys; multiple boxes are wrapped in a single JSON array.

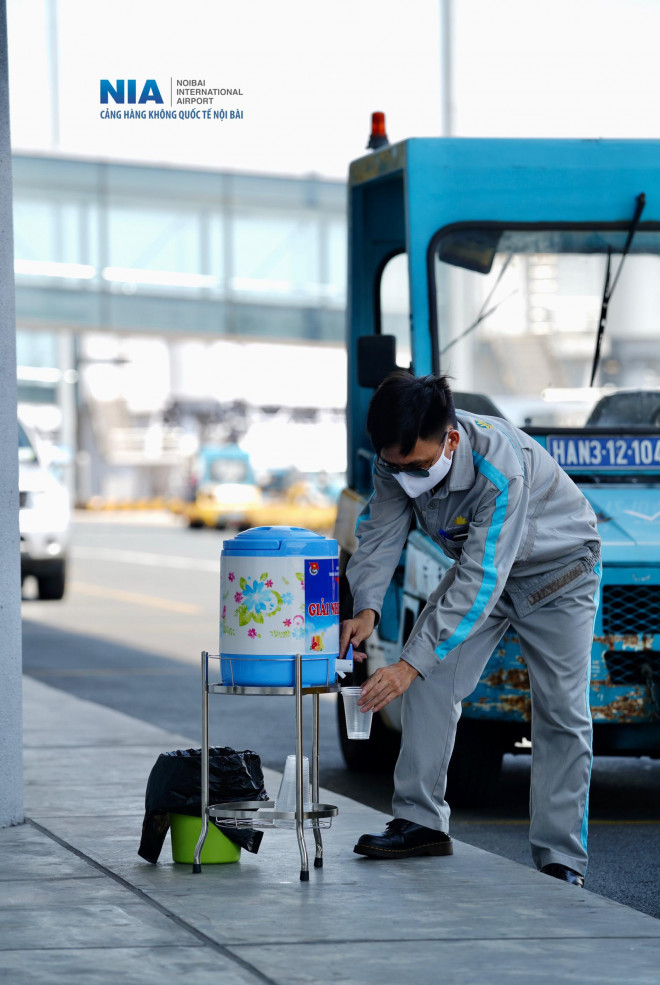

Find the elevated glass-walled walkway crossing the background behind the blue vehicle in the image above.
[{"left": 13, "top": 155, "right": 346, "bottom": 358}]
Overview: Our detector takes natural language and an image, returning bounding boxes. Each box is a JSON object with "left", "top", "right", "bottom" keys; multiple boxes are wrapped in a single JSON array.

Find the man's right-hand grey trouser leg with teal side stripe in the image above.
[{"left": 514, "top": 573, "right": 599, "bottom": 874}]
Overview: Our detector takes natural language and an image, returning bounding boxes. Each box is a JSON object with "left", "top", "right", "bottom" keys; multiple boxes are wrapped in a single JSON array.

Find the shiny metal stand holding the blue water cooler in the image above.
[{"left": 193, "top": 650, "right": 340, "bottom": 882}]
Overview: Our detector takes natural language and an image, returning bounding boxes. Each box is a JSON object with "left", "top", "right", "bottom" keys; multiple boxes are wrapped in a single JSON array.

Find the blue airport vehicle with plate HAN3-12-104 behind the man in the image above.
[{"left": 336, "top": 138, "right": 660, "bottom": 804}]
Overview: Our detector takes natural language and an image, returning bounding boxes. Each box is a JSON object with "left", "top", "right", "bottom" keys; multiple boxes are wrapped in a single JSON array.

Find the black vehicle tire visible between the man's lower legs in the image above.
[{"left": 447, "top": 718, "right": 505, "bottom": 807}]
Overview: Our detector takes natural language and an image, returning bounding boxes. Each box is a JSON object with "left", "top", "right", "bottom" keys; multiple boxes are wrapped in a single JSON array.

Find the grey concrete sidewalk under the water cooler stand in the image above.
[{"left": 0, "top": 678, "right": 660, "bottom": 985}]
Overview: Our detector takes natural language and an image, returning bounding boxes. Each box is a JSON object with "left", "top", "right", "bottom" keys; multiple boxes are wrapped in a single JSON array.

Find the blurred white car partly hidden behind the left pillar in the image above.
[{"left": 18, "top": 422, "right": 71, "bottom": 599}]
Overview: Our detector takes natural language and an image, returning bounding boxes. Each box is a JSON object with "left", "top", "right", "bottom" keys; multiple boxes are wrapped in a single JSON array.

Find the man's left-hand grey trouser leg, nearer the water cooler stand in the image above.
[{"left": 392, "top": 579, "right": 509, "bottom": 832}]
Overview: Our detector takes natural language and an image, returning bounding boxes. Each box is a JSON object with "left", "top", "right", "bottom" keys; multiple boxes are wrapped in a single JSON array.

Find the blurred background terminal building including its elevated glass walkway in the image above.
[{"left": 13, "top": 154, "right": 372, "bottom": 500}]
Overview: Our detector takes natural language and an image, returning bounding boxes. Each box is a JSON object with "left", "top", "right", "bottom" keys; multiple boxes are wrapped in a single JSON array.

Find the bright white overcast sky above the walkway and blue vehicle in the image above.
[{"left": 8, "top": 0, "right": 660, "bottom": 179}]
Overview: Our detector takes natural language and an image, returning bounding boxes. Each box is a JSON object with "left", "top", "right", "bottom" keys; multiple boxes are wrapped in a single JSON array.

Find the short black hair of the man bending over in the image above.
[{"left": 367, "top": 369, "right": 456, "bottom": 455}]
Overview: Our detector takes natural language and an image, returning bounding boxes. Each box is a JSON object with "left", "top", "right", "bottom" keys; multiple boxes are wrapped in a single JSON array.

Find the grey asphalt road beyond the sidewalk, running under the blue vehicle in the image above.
[{"left": 23, "top": 514, "right": 660, "bottom": 917}]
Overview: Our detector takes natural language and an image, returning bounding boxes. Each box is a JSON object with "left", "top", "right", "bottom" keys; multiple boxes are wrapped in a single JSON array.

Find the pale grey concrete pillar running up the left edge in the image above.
[{"left": 0, "top": 0, "right": 23, "bottom": 828}]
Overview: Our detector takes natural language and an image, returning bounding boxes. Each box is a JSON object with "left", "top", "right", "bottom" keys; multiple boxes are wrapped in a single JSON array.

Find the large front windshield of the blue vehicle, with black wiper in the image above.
[{"left": 432, "top": 231, "right": 660, "bottom": 428}]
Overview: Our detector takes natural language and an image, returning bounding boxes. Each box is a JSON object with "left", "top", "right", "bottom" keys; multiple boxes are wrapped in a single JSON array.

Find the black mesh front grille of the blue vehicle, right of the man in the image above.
[{"left": 602, "top": 585, "right": 660, "bottom": 684}]
